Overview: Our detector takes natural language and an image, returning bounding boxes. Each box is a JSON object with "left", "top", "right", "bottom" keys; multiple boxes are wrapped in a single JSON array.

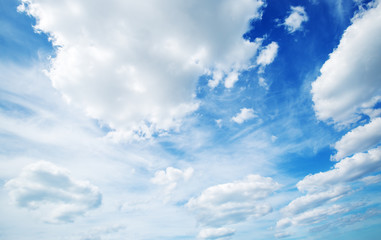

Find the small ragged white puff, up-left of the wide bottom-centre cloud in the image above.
[{"left": 151, "top": 167, "right": 194, "bottom": 190}]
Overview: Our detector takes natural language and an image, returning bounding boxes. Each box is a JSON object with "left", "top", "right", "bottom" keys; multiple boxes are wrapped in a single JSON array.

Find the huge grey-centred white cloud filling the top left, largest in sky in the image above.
[{"left": 19, "top": 0, "right": 264, "bottom": 138}]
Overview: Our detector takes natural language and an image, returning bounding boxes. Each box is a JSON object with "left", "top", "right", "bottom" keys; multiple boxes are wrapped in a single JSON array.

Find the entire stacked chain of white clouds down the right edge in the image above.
[{"left": 277, "top": 2, "right": 381, "bottom": 234}]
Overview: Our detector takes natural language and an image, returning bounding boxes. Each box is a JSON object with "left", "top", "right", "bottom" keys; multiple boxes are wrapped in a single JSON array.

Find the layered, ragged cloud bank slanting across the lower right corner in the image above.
[{"left": 277, "top": 147, "right": 381, "bottom": 232}]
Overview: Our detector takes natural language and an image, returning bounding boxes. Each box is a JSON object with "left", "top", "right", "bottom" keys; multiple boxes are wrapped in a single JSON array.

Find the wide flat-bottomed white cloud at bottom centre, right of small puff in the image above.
[{"left": 186, "top": 175, "right": 280, "bottom": 226}]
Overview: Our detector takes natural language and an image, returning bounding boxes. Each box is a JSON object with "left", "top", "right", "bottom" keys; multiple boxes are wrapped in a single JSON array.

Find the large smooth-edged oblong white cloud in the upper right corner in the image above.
[{"left": 311, "top": 4, "right": 381, "bottom": 125}]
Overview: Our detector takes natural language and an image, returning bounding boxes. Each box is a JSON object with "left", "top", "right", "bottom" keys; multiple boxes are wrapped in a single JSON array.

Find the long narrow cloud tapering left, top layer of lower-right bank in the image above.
[{"left": 297, "top": 147, "right": 381, "bottom": 191}]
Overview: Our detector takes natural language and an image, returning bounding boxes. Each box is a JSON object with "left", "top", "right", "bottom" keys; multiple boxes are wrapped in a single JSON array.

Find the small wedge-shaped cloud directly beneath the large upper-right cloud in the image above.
[{"left": 333, "top": 118, "right": 381, "bottom": 160}]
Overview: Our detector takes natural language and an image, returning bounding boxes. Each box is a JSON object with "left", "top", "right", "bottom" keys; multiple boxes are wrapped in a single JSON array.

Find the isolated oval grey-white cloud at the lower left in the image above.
[{"left": 5, "top": 161, "right": 102, "bottom": 223}]
